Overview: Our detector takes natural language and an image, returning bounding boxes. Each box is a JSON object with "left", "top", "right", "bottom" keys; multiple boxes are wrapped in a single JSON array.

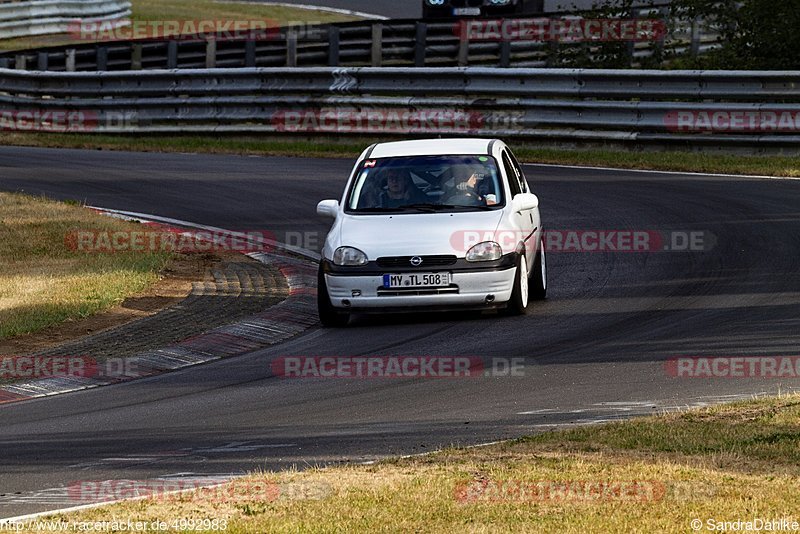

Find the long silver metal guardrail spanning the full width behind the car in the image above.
[{"left": 0, "top": 67, "right": 800, "bottom": 149}]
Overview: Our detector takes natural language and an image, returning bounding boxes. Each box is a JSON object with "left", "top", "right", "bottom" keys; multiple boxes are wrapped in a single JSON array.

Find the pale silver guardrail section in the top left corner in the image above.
[{"left": 0, "top": 0, "right": 131, "bottom": 39}]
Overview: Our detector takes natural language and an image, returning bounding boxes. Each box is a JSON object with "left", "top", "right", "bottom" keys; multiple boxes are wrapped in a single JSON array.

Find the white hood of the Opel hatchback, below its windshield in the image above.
[{"left": 339, "top": 210, "right": 503, "bottom": 260}]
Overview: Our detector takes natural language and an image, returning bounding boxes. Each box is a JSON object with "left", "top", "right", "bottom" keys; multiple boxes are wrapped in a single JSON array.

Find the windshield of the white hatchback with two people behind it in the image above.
[{"left": 347, "top": 156, "right": 504, "bottom": 213}]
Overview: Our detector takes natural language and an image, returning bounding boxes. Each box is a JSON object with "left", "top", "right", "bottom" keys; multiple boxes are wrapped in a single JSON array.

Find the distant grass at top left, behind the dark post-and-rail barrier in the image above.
[{"left": 0, "top": 0, "right": 357, "bottom": 50}]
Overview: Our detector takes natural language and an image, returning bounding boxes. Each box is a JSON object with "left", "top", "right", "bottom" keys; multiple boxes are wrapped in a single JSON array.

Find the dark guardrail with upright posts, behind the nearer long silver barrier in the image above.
[{"left": 0, "top": 6, "right": 720, "bottom": 71}]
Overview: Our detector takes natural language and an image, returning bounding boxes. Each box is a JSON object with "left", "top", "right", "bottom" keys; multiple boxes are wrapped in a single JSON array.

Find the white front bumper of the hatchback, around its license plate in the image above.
[{"left": 325, "top": 266, "right": 517, "bottom": 311}]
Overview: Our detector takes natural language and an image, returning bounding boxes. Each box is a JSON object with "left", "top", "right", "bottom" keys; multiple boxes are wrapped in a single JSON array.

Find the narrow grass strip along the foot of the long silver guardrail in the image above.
[{"left": 2, "top": 132, "right": 800, "bottom": 177}]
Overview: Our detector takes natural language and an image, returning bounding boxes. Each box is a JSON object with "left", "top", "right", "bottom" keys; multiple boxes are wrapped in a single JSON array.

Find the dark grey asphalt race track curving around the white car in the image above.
[{"left": 0, "top": 147, "right": 800, "bottom": 517}]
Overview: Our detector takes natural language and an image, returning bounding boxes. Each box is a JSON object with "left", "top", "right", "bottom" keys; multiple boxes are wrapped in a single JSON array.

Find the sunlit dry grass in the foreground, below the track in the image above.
[{"left": 36, "top": 395, "right": 800, "bottom": 534}]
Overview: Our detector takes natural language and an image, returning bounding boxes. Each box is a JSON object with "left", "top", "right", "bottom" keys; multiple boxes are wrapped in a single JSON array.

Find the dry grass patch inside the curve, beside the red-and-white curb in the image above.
[{"left": 0, "top": 193, "right": 171, "bottom": 340}]
